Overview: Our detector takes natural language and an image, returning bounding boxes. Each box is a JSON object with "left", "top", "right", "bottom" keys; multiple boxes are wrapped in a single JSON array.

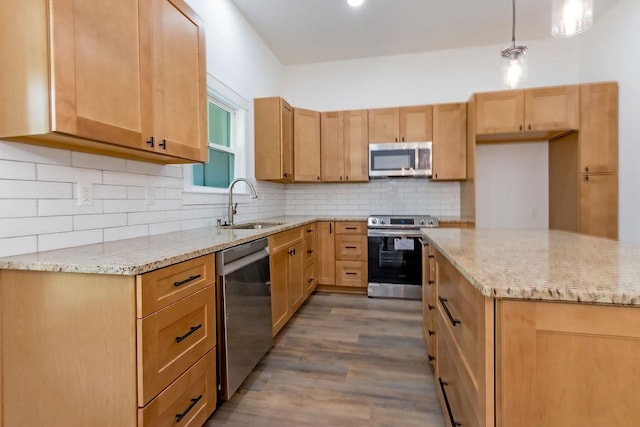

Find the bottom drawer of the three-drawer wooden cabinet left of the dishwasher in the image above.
[{"left": 138, "top": 350, "right": 217, "bottom": 427}]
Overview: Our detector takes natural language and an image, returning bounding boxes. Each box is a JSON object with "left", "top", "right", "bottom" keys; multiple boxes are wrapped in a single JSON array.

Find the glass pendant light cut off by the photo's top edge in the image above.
[{"left": 551, "top": 0, "right": 593, "bottom": 37}]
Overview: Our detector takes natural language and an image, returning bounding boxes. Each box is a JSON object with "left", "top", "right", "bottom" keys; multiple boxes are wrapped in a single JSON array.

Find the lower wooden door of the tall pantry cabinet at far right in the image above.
[{"left": 580, "top": 174, "right": 618, "bottom": 239}]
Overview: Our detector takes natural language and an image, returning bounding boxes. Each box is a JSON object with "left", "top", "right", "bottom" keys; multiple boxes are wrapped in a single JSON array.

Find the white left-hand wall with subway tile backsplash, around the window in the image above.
[{"left": 0, "top": 0, "right": 285, "bottom": 256}]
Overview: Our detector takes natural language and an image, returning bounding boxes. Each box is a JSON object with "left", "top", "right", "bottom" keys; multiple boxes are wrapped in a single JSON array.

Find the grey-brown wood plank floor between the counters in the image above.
[{"left": 205, "top": 294, "right": 444, "bottom": 427}]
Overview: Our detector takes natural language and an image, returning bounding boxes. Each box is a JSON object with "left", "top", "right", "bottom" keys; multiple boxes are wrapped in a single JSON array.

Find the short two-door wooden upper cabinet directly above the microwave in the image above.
[{"left": 369, "top": 105, "right": 433, "bottom": 144}]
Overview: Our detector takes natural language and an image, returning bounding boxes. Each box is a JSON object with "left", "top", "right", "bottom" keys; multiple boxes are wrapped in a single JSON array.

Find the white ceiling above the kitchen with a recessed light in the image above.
[{"left": 232, "top": 0, "right": 619, "bottom": 65}]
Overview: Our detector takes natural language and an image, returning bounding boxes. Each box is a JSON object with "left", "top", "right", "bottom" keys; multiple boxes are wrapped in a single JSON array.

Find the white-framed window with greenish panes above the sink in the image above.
[{"left": 193, "top": 97, "right": 236, "bottom": 188}]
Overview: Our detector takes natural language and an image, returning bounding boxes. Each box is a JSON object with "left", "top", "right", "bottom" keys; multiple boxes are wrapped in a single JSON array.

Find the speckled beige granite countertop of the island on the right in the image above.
[{"left": 422, "top": 229, "right": 640, "bottom": 306}]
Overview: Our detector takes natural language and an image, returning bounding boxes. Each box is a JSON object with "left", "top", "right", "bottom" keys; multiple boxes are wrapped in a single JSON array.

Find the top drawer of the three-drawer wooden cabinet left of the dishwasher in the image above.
[{"left": 136, "top": 255, "right": 215, "bottom": 319}]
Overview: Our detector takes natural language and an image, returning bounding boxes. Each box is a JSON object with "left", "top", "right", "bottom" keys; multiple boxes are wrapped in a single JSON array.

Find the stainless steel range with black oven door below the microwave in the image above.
[{"left": 367, "top": 215, "right": 439, "bottom": 300}]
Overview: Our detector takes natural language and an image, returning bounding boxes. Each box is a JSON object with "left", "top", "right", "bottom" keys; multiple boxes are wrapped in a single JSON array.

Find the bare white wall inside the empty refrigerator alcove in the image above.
[{"left": 476, "top": 142, "right": 549, "bottom": 229}]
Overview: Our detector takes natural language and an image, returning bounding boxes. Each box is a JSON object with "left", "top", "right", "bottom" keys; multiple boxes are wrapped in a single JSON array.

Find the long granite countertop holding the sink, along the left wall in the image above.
[{"left": 0, "top": 216, "right": 366, "bottom": 275}]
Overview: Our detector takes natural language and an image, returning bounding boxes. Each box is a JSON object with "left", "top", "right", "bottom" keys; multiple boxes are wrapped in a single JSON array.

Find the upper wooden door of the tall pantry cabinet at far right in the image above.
[{"left": 579, "top": 83, "right": 618, "bottom": 173}]
